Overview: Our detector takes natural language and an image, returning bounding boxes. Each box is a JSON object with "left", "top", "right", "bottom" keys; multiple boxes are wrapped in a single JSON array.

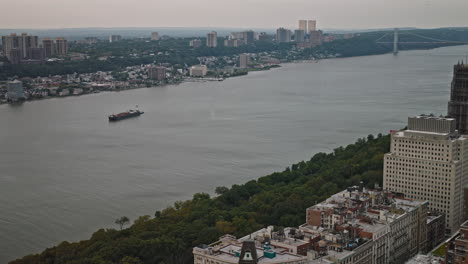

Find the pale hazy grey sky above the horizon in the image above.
[{"left": 0, "top": 0, "right": 468, "bottom": 29}]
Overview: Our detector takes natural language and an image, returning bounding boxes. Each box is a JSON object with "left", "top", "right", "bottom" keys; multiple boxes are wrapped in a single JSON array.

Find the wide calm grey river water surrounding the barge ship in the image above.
[{"left": 0, "top": 46, "right": 468, "bottom": 263}]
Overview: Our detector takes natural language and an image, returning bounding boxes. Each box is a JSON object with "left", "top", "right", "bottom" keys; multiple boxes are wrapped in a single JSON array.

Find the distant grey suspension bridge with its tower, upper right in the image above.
[{"left": 375, "top": 28, "right": 468, "bottom": 55}]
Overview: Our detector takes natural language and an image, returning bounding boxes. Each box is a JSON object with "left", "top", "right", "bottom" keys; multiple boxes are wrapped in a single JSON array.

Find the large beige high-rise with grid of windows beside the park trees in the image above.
[{"left": 383, "top": 116, "right": 468, "bottom": 234}]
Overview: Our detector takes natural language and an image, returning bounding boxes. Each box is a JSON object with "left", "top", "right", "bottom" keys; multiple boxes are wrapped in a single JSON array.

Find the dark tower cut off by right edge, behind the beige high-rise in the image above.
[{"left": 448, "top": 62, "right": 468, "bottom": 135}]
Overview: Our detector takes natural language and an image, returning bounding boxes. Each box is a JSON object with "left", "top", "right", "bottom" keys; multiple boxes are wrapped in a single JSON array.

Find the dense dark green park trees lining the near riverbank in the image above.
[{"left": 10, "top": 134, "right": 390, "bottom": 264}]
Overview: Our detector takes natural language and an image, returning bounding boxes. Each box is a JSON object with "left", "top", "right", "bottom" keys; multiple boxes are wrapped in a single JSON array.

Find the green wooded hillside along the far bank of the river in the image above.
[{"left": 0, "top": 28, "right": 468, "bottom": 80}]
